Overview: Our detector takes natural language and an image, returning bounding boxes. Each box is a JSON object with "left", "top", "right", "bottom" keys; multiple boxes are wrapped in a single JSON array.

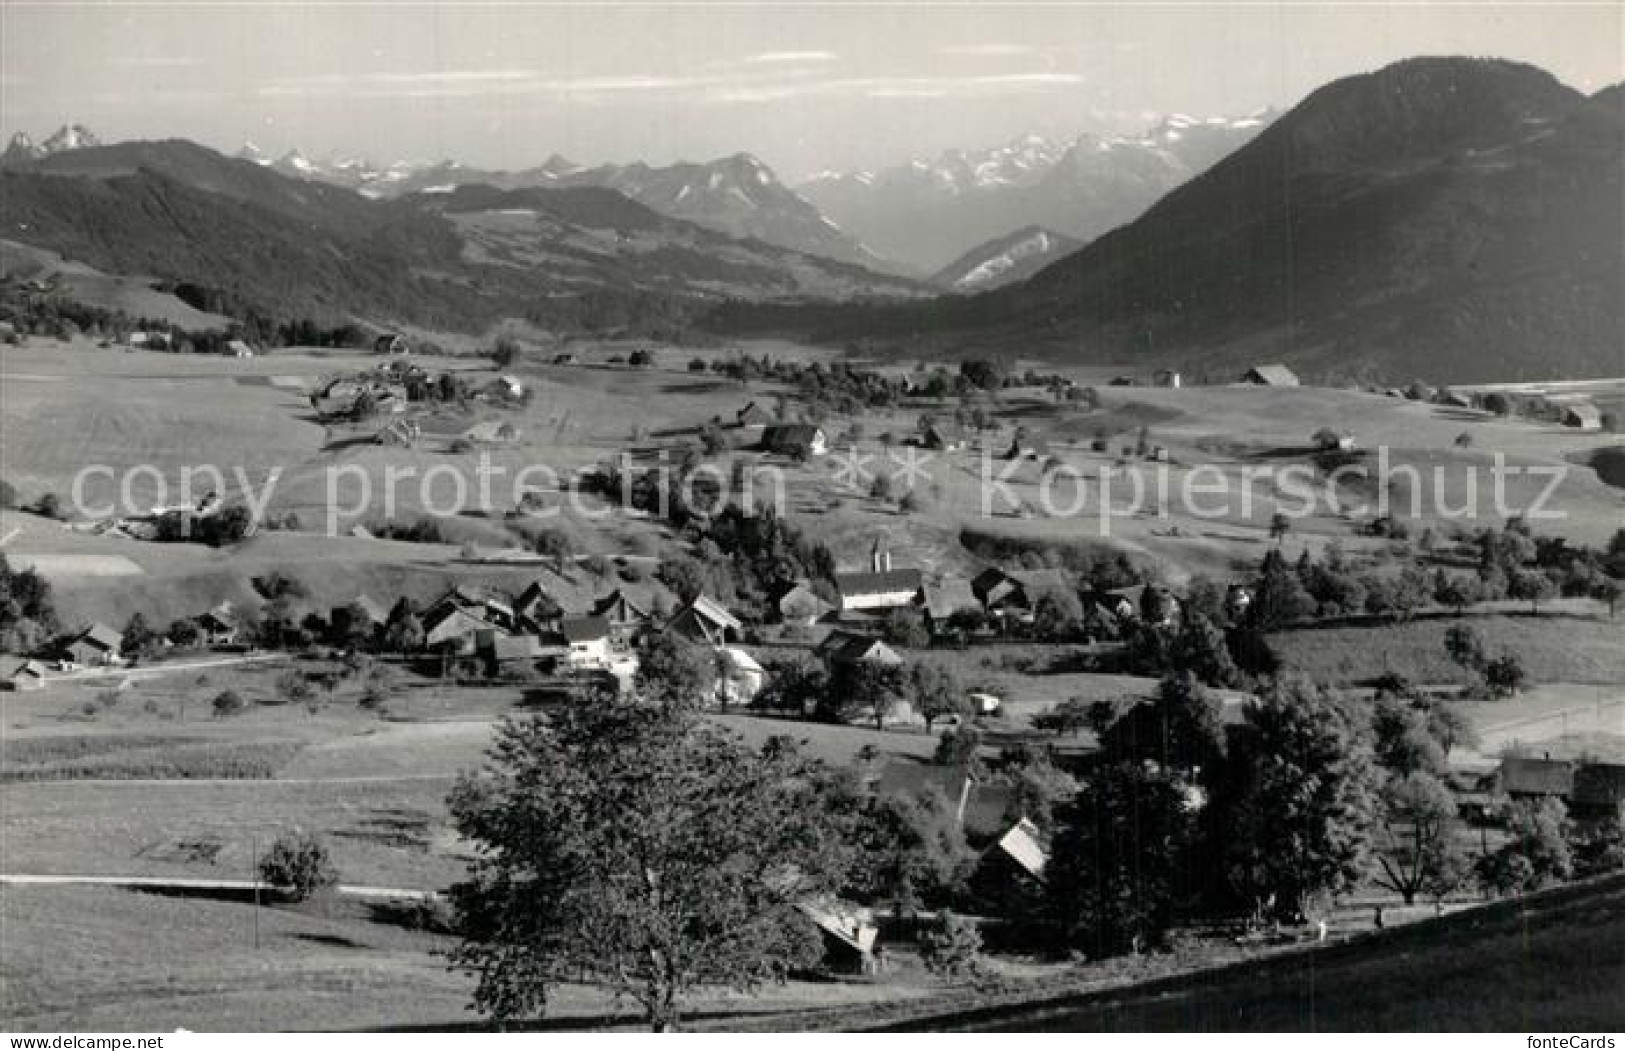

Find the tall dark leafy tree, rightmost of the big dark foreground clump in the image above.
[{"left": 1229, "top": 677, "right": 1376, "bottom": 918}]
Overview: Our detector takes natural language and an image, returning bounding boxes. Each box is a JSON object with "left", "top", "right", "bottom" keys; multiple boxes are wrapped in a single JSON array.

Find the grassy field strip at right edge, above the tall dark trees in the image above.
[{"left": 1269, "top": 616, "right": 1625, "bottom": 684}]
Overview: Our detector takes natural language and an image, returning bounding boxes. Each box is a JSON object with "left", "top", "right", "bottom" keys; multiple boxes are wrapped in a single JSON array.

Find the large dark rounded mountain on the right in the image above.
[{"left": 731, "top": 57, "right": 1625, "bottom": 382}]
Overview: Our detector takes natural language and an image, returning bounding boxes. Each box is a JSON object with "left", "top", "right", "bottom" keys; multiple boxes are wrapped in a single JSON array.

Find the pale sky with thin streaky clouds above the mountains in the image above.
[{"left": 0, "top": 0, "right": 1625, "bottom": 180}]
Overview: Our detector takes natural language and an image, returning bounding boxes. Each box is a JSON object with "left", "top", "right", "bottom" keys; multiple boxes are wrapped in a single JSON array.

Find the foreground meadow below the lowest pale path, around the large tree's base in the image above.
[{"left": 0, "top": 887, "right": 933, "bottom": 1033}]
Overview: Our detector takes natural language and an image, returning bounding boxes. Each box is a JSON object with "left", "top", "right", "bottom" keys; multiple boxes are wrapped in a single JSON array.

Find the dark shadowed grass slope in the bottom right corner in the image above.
[{"left": 890, "top": 877, "right": 1625, "bottom": 1032}]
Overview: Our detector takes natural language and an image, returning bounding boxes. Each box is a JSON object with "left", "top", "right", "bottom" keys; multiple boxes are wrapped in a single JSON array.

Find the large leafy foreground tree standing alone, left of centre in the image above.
[{"left": 450, "top": 689, "right": 852, "bottom": 1032}]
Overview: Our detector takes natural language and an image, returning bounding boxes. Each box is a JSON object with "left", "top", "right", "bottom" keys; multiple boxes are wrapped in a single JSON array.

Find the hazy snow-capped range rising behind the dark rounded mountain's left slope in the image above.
[{"left": 796, "top": 110, "right": 1274, "bottom": 273}]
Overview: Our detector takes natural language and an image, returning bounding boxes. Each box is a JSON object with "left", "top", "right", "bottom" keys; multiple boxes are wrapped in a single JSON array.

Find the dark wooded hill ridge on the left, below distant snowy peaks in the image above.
[{"left": 0, "top": 140, "right": 926, "bottom": 331}]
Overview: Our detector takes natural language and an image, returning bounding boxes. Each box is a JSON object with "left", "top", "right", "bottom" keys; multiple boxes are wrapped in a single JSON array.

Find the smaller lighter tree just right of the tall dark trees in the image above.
[{"left": 1376, "top": 772, "right": 1466, "bottom": 905}]
